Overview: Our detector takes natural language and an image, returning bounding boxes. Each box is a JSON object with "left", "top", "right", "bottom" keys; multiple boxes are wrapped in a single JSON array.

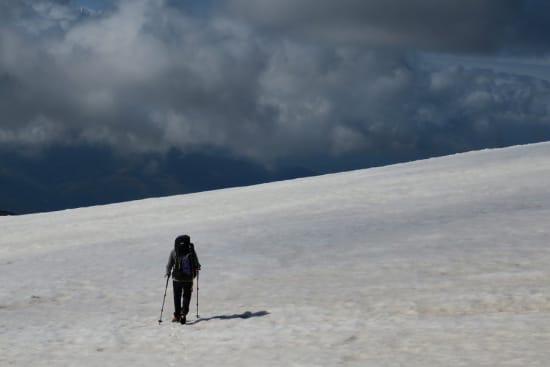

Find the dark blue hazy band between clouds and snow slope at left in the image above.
[{"left": 0, "top": 147, "right": 315, "bottom": 215}]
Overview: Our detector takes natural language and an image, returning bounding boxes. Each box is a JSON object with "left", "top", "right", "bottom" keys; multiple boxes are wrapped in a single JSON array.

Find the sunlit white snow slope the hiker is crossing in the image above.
[{"left": 0, "top": 143, "right": 550, "bottom": 367}]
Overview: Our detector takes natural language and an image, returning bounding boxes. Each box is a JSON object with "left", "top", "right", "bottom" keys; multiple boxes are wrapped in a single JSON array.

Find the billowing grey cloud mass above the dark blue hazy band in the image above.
[{"left": 0, "top": 0, "right": 550, "bottom": 162}]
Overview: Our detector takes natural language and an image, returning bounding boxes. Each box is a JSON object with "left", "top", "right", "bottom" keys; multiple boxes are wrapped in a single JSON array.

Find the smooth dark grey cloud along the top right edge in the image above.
[{"left": 227, "top": 0, "right": 550, "bottom": 52}]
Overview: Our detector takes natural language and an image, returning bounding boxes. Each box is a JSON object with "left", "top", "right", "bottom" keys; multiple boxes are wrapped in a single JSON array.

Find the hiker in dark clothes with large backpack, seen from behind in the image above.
[{"left": 165, "top": 234, "right": 201, "bottom": 324}]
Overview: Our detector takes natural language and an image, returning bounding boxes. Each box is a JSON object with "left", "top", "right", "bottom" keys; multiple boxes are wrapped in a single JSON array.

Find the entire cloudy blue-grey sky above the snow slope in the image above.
[{"left": 0, "top": 0, "right": 550, "bottom": 212}]
